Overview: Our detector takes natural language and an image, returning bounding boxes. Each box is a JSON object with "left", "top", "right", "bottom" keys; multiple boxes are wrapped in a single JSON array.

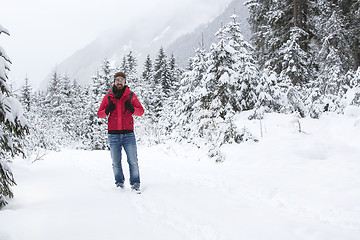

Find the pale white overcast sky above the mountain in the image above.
[{"left": 0, "top": 0, "right": 232, "bottom": 88}]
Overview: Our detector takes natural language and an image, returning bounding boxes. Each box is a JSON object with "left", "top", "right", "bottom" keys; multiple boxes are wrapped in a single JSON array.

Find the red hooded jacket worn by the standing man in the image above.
[{"left": 97, "top": 87, "right": 144, "bottom": 131}]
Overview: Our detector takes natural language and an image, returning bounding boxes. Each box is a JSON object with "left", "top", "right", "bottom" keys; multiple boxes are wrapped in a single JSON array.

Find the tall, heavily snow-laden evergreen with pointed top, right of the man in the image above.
[{"left": 192, "top": 19, "right": 258, "bottom": 161}]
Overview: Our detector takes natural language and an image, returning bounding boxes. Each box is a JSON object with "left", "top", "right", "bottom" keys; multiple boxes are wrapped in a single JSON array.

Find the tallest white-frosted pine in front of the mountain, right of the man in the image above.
[{"left": 194, "top": 21, "right": 250, "bottom": 161}]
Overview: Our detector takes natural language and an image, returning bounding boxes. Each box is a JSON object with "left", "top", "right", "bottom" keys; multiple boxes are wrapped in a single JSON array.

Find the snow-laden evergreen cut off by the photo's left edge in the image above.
[{"left": 0, "top": 25, "right": 28, "bottom": 208}]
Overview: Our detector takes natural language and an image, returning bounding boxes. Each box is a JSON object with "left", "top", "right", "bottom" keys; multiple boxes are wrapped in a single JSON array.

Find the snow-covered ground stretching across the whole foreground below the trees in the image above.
[{"left": 0, "top": 109, "right": 360, "bottom": 240}]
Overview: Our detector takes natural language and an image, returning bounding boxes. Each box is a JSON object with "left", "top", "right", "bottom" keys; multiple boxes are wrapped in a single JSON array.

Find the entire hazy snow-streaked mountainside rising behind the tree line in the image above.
[{"left": 40, "top": 0, "right": 250, "bottom": 89}]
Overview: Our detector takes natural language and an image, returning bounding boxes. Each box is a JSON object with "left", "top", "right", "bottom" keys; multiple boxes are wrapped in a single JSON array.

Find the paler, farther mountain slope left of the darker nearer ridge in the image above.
[{"left": 42, "top": 0, "right": 239, "bottom": 88}]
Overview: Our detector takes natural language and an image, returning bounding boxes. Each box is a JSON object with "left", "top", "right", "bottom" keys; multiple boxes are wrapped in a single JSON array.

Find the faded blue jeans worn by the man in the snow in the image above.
[{"left": 108, "top": 133, "right": 140, "bottom": 188}]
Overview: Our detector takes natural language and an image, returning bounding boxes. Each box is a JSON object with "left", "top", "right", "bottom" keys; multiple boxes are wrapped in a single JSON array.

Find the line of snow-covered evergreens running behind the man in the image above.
[{"left": 16, "top": 9, "right": 360, "bottom": 161}]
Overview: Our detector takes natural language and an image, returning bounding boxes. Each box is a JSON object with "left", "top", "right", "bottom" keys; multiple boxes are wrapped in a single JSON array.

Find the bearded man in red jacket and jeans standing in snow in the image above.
[{"left": 97, "top": 72, "right": 144, "bottom": 193}]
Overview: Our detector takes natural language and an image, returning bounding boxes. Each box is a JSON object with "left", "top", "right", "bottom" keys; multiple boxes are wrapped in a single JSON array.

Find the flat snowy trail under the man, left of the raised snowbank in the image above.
[{"left": 0, "top": 149, "right": 357, "bottom": 240}]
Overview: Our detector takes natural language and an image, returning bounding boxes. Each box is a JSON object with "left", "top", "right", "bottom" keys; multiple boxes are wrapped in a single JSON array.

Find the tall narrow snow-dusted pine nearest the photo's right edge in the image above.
[{"left": 317, "top": 6, "right": 356, "bottom": 112}]
